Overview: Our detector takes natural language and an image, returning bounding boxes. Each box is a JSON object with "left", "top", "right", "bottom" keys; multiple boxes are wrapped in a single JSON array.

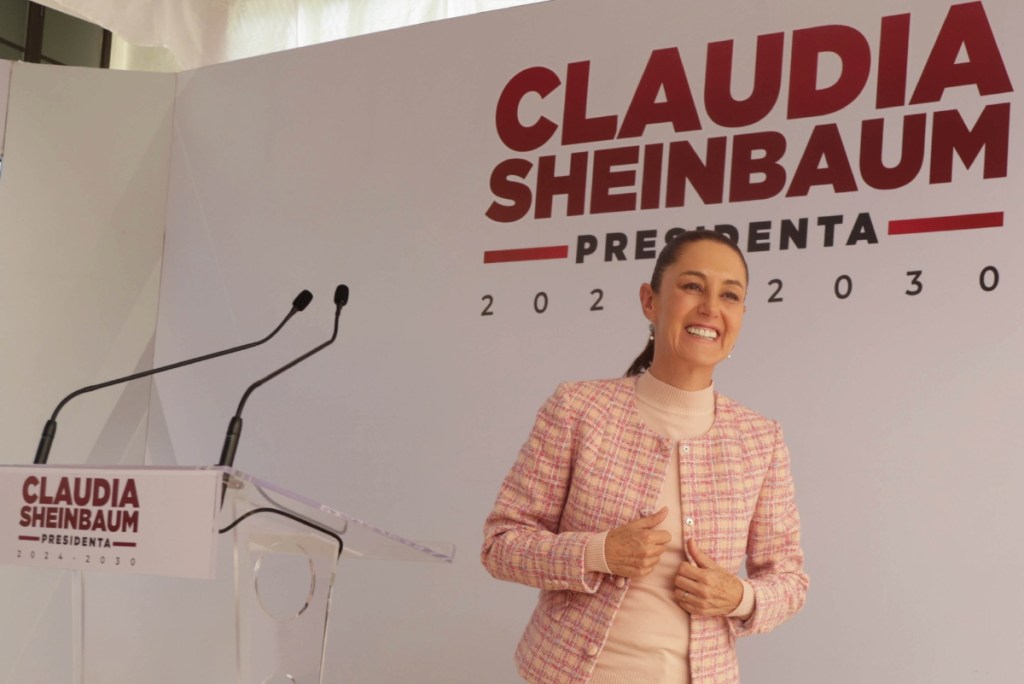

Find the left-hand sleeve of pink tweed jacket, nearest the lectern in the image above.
[{"left": 480, "top": 385, "right": 602, "bottom": 593}]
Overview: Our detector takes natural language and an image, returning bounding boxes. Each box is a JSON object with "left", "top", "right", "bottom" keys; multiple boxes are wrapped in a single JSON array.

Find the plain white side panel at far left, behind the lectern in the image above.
[{"left": 0, "top": 62, "right": 174, "bottom": 682}]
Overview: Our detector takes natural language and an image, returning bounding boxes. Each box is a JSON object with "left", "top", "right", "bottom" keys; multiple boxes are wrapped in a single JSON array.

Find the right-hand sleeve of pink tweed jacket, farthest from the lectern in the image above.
[{"left": 729, "top": 425, "right": 808, "bottom": 636}]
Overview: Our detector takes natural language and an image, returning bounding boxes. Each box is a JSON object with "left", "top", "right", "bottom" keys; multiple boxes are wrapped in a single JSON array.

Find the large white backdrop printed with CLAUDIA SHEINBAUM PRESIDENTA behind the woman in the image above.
[{"left": 6, "top": 0, "right": 1024, "bottom": 684}]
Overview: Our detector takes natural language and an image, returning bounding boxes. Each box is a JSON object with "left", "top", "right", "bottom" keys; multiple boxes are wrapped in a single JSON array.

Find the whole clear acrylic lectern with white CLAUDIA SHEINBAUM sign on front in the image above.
[{"left": 0, "top": 466, "right": 454, "bottom": 684}]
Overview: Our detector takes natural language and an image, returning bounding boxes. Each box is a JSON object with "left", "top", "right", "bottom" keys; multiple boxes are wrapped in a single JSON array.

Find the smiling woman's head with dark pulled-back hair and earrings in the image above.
[{"left": 640, "top": 240, "right": 746, "bottom": 390}]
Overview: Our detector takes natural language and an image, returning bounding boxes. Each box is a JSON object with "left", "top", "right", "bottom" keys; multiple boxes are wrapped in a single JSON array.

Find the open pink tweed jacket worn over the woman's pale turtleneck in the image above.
[{"left": 481, "top": 378, "right": 808, "bottom": 684}]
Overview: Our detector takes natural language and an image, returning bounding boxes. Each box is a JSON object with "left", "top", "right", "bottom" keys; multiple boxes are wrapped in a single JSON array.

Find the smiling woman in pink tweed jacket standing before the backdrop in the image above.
[{"left": 481, "top": 231, "right": 808, "bottom": 684}]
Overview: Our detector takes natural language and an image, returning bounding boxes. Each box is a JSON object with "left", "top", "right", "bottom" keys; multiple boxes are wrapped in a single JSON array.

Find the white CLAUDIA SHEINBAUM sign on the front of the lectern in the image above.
[{"left": 0, "top": 466, "right": 221, "bottom": 578}]
